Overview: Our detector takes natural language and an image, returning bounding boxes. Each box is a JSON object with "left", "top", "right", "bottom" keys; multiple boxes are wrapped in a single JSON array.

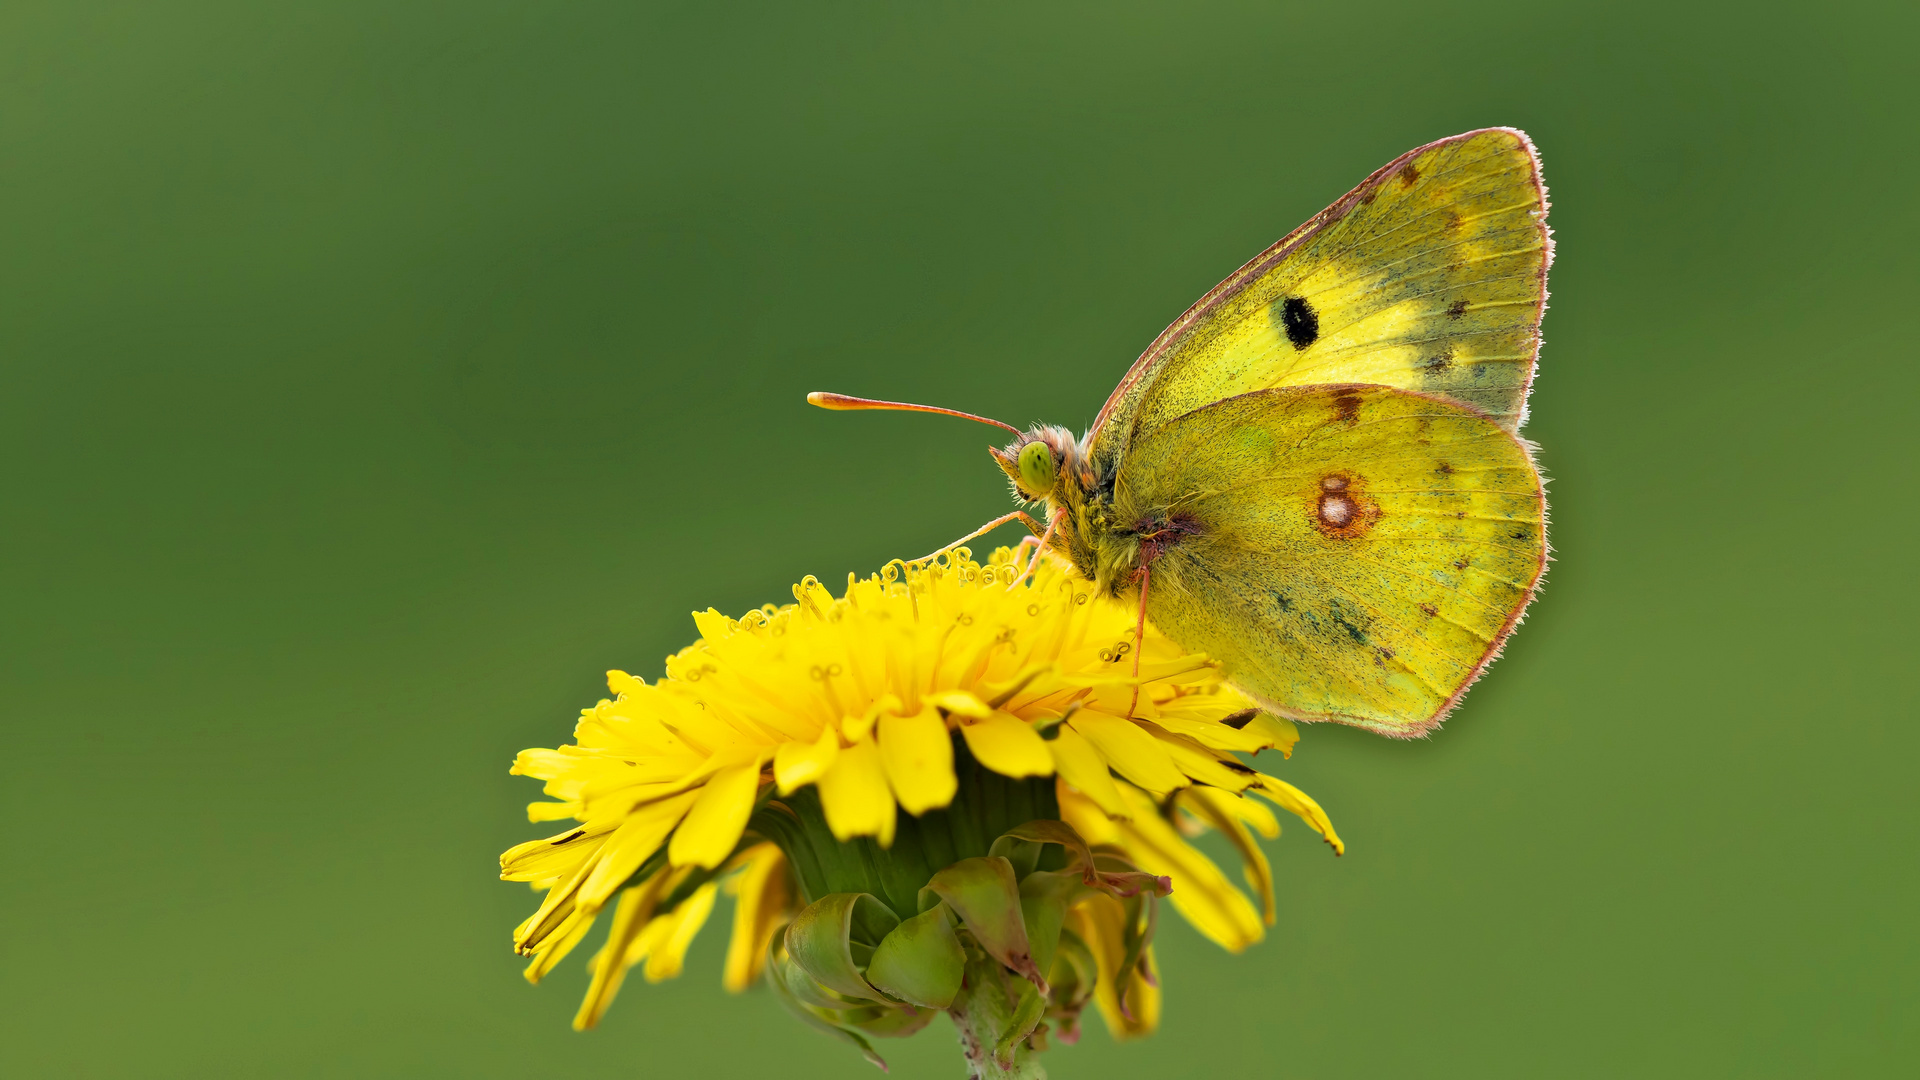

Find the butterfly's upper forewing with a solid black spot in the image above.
[{"left": 1092, "top": 129, "right": 1551, "bottom": 465}]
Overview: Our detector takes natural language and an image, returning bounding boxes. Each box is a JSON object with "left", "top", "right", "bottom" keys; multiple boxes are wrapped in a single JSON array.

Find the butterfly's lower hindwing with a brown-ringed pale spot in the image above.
[{"left": 1114, "top": 386, "right": 1546, "bottom": 736}]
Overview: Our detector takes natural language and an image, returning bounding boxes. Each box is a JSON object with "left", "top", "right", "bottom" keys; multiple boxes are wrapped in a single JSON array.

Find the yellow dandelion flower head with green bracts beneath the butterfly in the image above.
[{"left": 501, "top": 548, "right": 1340, "bottom": 1076}]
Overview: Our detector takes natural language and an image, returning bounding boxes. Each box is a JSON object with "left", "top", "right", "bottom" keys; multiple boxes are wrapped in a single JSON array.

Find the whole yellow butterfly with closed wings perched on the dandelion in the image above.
[{"left": 808, "top": 129, "right": 1553, "bottom": 738}]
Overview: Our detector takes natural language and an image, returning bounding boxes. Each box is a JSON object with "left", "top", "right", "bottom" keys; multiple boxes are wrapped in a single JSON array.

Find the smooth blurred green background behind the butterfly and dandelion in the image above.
[{"left": 0, "top": 0, "right": 1920, "bottom": 1080}]
